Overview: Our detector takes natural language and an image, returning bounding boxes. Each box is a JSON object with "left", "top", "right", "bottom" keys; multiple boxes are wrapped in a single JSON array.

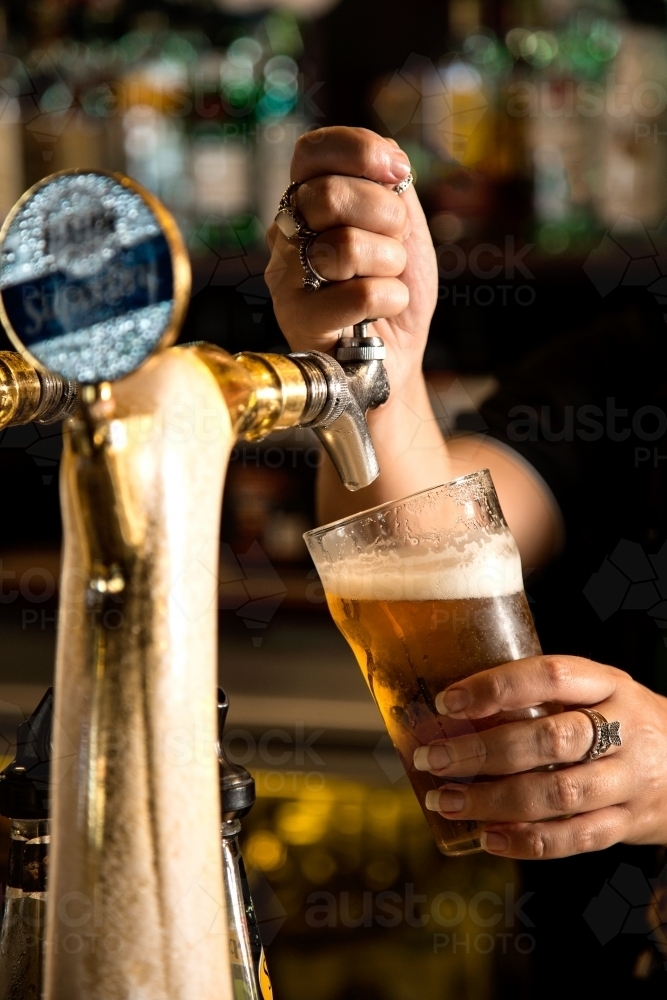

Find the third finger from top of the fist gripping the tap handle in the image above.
[{"left": 308, "top": 227, "right": 407, "bottom": 281}]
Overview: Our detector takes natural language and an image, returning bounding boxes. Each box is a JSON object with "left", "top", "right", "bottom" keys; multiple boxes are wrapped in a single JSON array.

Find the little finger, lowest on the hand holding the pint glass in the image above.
[{"left": 481, "top": 805, "right": 630, "bottom": 861}]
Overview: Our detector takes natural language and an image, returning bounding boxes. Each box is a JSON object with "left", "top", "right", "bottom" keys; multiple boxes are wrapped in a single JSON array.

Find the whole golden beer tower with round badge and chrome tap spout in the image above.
[{"left": 0, "top": 171, "right": 389, "bottom": 1000}]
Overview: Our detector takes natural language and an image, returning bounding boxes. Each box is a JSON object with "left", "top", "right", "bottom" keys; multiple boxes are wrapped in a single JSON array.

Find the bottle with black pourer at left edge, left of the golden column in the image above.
[{"left": 0, "top": 688, "right": 53, "bottom": 1000}]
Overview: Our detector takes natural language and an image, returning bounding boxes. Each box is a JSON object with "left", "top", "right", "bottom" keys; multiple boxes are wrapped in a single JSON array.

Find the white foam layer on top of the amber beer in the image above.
[{"left": 318, "top": 532, "right": 523, "bottom": 601}]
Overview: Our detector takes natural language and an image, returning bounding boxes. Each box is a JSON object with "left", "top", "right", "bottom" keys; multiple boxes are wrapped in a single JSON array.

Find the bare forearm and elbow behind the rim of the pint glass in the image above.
[{"left": 317, "top": 372, "right": 562, "bottom": 568}]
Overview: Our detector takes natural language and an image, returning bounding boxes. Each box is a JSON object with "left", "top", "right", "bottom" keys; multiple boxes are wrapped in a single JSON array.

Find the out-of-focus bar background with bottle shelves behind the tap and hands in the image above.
[{"left": 0, "top": 0, "right": 667, "bottom": 1000}]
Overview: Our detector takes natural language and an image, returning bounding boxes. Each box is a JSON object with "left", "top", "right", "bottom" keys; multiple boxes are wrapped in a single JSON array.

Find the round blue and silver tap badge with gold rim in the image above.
[{"left": 0, "top": 172, "right": 187, "bottom": 383}]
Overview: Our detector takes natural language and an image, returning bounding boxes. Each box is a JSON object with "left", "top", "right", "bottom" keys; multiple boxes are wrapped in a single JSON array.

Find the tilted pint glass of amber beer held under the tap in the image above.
[{"left": 304, "top": 470, "right": 548, "bottom": 855}]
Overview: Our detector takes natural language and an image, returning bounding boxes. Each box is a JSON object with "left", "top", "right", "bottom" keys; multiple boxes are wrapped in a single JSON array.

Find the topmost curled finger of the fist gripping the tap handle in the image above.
[{"left": 292, "top": 126, "right": 410, "bottom": 184}]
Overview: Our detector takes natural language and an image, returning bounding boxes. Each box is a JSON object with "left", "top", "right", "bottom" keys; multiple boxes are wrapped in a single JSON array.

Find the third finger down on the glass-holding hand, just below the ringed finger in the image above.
[{"left": 425, "top": 759, "right": 636, "bottom": 823}]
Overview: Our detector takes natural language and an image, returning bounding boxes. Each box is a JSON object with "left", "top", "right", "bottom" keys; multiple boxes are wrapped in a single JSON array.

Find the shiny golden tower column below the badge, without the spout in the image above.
[{"left": 45, "top": 350, "right": 235, "bottom": 1000}]
